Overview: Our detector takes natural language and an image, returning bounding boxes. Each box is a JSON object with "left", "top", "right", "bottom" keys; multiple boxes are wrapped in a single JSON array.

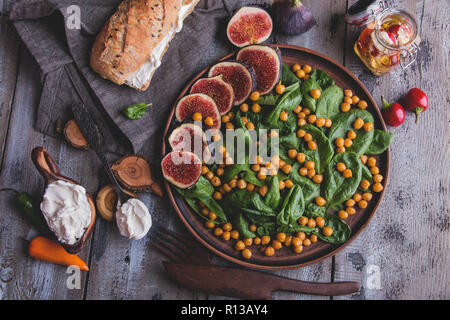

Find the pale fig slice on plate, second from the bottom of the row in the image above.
[{"left": 169, "top": 123, "right": 211, "bottom": 162}]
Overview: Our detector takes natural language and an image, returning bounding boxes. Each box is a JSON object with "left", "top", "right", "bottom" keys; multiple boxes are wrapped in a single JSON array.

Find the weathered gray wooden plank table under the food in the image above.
[{"left": 0, "top": 0, "right": 450, "bottom": 299}]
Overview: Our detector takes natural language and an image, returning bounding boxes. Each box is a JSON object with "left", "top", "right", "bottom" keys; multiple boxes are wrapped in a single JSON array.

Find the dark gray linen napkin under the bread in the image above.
[{"left": 9, "top": 0, "right": 270, "bottom": 152}]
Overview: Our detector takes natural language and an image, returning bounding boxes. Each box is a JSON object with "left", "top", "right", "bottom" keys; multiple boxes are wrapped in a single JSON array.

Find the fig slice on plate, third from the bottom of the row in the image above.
[{"left": 175, "top": 93, "right": 221, "bottom": 129}]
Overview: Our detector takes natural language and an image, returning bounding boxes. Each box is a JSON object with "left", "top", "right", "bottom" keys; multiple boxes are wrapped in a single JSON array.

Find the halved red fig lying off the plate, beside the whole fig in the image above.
[{"left": 227, "top": 7, "right": 273, "bottom": 48}]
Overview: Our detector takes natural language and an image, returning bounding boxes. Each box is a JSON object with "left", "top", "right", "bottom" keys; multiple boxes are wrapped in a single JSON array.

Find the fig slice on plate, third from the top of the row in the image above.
[{"left": 191, "top": 75, "right": 234, "bottom": 115}]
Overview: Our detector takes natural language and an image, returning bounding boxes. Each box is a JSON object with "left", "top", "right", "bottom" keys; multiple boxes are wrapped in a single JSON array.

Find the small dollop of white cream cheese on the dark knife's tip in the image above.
[{"left": 116, "top": 199, "right": 152, "bottom": 240}]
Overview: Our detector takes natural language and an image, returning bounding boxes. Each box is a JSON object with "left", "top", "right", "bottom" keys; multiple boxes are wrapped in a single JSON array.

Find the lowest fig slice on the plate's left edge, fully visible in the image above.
[{"left": 161, "top": 151, "right": 202, "bottom": 189}]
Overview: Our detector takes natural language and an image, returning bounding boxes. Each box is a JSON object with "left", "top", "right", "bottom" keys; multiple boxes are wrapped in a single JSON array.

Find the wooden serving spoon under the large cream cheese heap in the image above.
[{"left": 31, "top": 147, "right": 96, "bottom": 253}]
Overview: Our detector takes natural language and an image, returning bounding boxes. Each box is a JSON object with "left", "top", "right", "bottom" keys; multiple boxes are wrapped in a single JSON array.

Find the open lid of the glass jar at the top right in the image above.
[{"left": 345, "top": 0, "right": 388, "bottom": 26}]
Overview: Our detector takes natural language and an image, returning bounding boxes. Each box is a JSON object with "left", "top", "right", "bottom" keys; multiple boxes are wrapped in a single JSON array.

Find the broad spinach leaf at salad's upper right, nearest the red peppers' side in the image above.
[{"left": 328, "top": 109, "right": 374, "bottom": 156}]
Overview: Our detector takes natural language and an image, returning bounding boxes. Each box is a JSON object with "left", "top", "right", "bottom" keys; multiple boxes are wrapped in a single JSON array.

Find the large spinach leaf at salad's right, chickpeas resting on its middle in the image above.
[{"left": 321, "top": 152, "right": 362, "bottom": 208}]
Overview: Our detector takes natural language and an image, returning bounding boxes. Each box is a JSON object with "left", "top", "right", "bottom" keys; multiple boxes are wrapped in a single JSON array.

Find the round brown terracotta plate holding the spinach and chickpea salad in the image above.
[{"left": 162, "top": 44, "right": 390, "bottom": 270}]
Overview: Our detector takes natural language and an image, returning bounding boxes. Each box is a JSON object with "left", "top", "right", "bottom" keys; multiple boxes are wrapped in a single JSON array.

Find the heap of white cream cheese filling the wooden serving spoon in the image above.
[{"left": 41, "top": 180, "right": 92, "bottom": 244}]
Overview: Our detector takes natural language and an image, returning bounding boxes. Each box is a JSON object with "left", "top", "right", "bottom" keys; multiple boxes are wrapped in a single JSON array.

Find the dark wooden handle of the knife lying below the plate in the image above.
[{"left": 274, "top": 278, "right": 360, "bottom": 296}]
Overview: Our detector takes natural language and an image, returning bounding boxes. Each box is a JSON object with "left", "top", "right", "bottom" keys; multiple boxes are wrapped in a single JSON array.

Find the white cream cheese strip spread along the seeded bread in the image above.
[{"left": 125, "top": 3, "right": 197, "bottom": 88}]
